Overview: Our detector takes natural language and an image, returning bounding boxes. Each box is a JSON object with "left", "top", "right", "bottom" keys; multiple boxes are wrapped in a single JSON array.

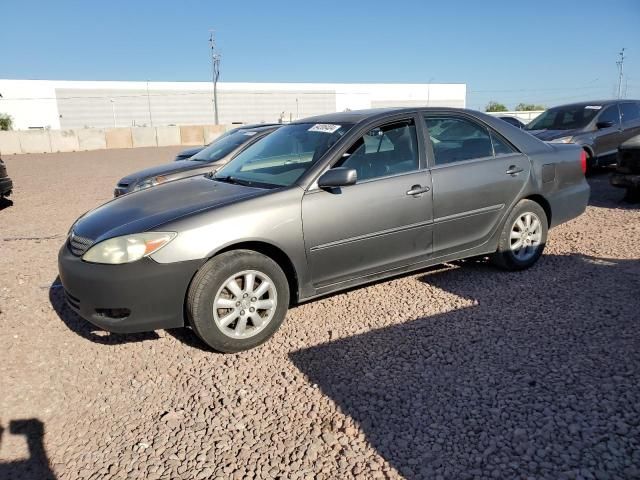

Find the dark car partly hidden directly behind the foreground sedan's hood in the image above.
[{"left": 113, "top": 125, "right": 280, "bottom": 197}]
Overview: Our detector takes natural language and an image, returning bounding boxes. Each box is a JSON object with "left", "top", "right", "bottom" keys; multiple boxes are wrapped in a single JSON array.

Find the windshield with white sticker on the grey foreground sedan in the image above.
[{"left": 213, "top": 123, "right": 353, "bottom": 188}]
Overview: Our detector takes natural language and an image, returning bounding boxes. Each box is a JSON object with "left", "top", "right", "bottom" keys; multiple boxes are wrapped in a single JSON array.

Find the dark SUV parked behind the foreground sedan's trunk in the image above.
[{"left": 524, "top": 100, "right": 640, "bottom": 168}]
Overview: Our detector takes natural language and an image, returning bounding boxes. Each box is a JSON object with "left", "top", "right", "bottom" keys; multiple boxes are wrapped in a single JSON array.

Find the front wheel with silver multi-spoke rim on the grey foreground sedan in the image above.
[{"left": 187, "top": 250, "right": 289, "bottom": 353}]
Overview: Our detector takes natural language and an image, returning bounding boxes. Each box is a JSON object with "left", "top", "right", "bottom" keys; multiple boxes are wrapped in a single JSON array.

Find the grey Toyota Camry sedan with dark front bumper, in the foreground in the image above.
[{"left": 59, "top": 108, "right": 589, "bottom": 352}]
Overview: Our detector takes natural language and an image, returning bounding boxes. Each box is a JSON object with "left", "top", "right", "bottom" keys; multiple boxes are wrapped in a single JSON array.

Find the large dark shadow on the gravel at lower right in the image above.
[{"left": 290, "top": 255, "right": 640, "bottom": 479}]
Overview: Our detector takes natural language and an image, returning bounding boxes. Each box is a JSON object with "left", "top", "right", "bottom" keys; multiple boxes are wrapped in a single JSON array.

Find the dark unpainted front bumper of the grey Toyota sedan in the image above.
[{"left": 58, "top": 243, "right": 202, "bottom": 333}]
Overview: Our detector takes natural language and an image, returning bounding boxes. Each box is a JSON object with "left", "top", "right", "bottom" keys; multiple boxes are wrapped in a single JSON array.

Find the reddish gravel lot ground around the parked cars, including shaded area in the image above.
[{"left": 0, "top": 148, "right": 640, "bottom": 479}]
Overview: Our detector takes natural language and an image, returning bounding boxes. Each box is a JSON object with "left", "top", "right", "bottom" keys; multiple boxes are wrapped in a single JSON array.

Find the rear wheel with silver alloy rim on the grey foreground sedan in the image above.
[{"left": 491, "top": 200, "right": 548, "bottom": 271}]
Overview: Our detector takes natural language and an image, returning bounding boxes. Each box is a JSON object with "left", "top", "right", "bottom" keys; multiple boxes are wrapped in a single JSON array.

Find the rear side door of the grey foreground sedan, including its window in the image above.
[{"left": 424, "top": 113, "right": 531, "bottom": 257}]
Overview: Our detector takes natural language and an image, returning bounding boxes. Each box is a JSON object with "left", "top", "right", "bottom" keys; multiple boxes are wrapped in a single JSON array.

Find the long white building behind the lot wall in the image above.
[{"left": 0, "top": 79, "right": 466, "bottom": 130}]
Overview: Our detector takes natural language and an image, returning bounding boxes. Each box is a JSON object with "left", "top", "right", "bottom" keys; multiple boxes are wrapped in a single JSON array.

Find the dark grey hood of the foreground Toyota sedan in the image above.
[{"left": 73, "top": 176, "right": 269, "bottom": 242}]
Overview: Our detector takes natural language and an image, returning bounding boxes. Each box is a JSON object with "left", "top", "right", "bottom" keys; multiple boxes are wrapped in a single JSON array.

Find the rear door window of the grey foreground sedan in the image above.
[{"left": 425, "top": 116, "right": 493, "bottom": 165}]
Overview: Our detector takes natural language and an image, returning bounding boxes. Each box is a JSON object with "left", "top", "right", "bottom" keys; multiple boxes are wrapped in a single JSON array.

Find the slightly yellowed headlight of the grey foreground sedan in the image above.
[{"left": 82, "top": 232, "right": 177, "bottom": 265}]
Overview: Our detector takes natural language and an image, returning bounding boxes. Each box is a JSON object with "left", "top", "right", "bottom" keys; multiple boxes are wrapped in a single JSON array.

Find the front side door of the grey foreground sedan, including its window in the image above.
[{"left": 302, "top": 118, "right": 432, "bottom": 290}]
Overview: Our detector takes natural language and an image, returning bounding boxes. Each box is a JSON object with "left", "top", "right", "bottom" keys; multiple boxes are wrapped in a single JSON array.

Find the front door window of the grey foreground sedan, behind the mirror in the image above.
[{"left": 334, "top": 120, "right": 419, "bottom": 182}]
